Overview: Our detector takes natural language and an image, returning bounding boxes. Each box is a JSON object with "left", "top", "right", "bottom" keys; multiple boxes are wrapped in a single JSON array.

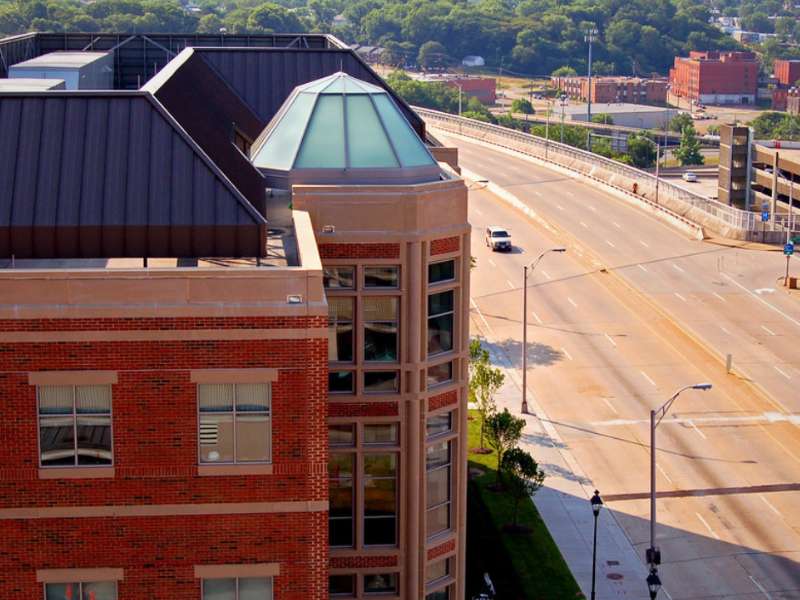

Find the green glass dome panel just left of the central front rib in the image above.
[{"left": 295, "top": 95, "right": 345, "bottom": 169}]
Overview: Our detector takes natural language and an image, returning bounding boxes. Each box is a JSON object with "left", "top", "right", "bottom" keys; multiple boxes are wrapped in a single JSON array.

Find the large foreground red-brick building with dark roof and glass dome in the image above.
[{"left": 0, "top": 34, "right": 470, "bottom": 600}]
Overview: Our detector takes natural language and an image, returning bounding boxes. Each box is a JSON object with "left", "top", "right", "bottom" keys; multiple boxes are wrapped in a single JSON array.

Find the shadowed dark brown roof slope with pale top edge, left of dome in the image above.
[{"left": 142, "top": 48, "right": 265, "bottom": 213}]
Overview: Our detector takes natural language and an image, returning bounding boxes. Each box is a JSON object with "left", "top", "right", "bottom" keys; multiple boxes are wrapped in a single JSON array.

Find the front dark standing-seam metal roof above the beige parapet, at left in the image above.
[{"left": 0, "top": 91, "right": 266, "bottom": 258}]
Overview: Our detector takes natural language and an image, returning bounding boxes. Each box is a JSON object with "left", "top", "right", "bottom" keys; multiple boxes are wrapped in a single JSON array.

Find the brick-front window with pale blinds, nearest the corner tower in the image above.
[{"left": 197, "top": 383, "right": 272, "bottom": 464}]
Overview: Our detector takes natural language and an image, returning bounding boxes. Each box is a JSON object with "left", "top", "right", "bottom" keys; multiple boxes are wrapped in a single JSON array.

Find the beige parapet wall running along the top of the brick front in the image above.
[{"left": 0, "top": 211, "right": 327, "bottom": 319}]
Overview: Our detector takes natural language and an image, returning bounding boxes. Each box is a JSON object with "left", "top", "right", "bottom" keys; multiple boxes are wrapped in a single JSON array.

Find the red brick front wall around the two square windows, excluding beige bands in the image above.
[{"left": 0, "top": 317, "right": 327, "bottom": 600}]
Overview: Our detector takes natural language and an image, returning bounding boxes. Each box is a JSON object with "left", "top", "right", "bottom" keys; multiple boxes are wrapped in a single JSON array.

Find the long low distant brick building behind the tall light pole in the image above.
[{"left": 552, "top": 77, "right": 667, "bottom": 104}]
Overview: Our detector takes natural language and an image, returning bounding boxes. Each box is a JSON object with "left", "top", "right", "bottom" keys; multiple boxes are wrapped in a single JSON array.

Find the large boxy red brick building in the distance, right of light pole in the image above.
[{"left": 669, "top": 51, "right": 758, "bottom": 104}]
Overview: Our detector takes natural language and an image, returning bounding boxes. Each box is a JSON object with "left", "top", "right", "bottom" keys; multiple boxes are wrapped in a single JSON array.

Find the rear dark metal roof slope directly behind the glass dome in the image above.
[{"left": 195, "top": 48, "right": 425, "bottom": 139}]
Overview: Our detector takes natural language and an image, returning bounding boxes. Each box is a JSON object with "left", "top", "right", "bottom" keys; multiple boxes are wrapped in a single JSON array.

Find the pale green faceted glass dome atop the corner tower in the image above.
[{"left": 251, "top": 72, "right": 439, "bottom": 183}]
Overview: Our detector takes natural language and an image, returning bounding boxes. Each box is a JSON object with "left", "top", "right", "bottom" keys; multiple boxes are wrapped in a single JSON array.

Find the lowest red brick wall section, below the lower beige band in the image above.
[{"left": 0, "top": 513, "right": 328, "bottom": 600}]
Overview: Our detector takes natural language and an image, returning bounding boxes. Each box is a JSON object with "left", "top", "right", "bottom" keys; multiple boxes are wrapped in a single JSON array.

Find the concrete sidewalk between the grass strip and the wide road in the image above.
[{"left": 473, "top": 328, "right": 648, "bottom": 600}]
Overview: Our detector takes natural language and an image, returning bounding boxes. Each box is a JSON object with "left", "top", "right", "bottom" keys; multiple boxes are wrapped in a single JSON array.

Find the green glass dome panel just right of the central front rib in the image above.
[{"left": 345, "top": 94, "right": 400, "bottom": 169}]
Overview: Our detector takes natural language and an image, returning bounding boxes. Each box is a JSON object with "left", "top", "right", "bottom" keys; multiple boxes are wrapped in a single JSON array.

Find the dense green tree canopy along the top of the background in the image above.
[{"left": 0, "top": 0, "right": 744, "bottom": 75}]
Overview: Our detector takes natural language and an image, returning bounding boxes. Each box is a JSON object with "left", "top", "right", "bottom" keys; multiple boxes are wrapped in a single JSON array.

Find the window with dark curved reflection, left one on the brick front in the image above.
[{"left": 37, "top": 385, "right": 113, "bottom": 467}]
